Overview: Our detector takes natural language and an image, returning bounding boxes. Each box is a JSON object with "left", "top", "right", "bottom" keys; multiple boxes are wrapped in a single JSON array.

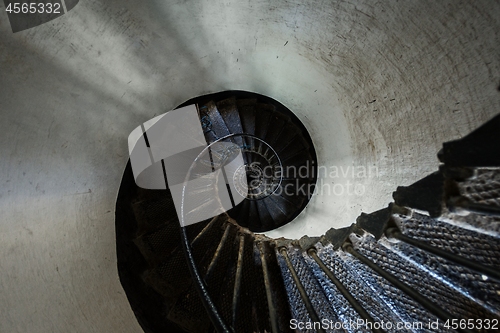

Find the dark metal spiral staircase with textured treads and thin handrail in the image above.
[{"left": 116, "top": 92, "right": 500, "bottom": 333}]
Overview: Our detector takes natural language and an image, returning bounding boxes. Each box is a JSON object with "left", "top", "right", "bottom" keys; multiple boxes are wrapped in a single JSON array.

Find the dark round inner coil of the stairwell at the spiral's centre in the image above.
[{"left": 174, "top": 90, "right": 318, "bottom": 232}]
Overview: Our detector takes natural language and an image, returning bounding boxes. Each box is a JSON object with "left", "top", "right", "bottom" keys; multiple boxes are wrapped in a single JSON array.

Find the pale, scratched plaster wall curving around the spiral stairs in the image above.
[{"left": 0, "top": 0, "right": 500, "bottom": 333}]
